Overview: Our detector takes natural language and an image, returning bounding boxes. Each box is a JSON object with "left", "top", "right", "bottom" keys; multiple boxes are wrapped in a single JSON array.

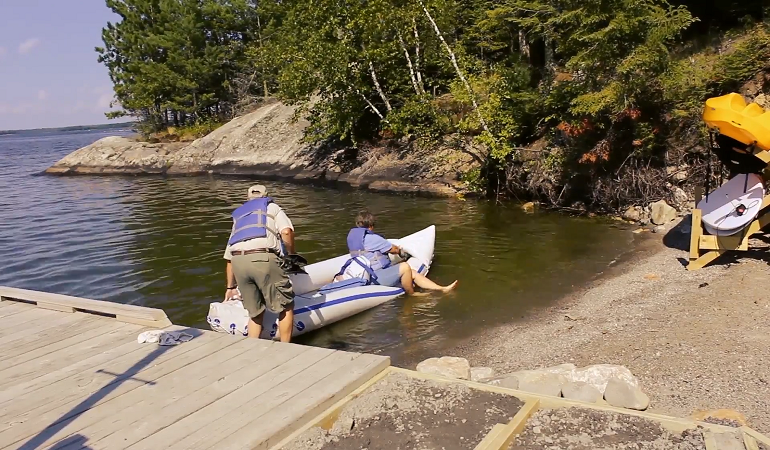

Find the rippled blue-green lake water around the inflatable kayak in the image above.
[{"left": 0, "top": 131, "right": 632, "bottom": 363}]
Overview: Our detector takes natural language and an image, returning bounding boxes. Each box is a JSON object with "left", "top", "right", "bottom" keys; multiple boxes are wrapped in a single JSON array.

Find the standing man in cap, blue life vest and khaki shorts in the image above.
[{"left": 225, "top": 184, "right": 294, "bottom": 342}]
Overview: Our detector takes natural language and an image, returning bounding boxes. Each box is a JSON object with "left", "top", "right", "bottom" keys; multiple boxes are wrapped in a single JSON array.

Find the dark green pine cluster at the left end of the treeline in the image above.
[{"left": 96, "top": 0, "right": 255, "bottom": 130}]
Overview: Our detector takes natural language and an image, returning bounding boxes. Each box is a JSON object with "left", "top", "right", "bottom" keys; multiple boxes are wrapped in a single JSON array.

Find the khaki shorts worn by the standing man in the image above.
[{"left": 232, "top": 253, "right": 294, "bottom": 318}]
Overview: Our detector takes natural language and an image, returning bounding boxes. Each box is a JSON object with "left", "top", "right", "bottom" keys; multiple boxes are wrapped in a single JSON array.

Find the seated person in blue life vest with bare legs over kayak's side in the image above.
[{"left": 343, "top": 210, "right": 457, "bottom": 295}]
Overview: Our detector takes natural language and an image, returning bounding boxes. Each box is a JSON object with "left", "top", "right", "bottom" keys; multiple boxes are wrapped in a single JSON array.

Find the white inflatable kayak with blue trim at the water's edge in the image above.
[{"left": 260, "top": 225, "right": 436, "bottom": 339}]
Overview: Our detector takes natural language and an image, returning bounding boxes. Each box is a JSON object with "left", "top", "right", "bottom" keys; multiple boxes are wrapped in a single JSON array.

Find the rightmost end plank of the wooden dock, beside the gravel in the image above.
[{"left": 236, "top": 354, "right": 390, "bottom": 449}]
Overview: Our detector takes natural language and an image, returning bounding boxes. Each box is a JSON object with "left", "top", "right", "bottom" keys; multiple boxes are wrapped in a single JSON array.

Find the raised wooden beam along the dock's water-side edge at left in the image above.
[{"left": 0, "top": 286, "right": 168, "bottom": 321}]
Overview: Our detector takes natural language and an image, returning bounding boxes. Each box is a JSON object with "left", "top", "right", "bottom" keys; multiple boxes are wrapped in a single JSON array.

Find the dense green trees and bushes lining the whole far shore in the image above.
[{"left": 98, "top": 0, "right": 770, "bottom": 207}]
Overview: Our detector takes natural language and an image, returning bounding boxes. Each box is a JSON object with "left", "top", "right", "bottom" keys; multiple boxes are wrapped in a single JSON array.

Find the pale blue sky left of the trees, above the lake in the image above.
[{"left": 0, "top": 0, "right": 130, "bottom": 130}]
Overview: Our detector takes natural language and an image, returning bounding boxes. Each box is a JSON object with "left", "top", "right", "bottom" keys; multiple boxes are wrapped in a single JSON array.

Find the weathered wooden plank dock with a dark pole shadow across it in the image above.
[{"left": 0, "top": 287, "right": 390, "bottom": 450}]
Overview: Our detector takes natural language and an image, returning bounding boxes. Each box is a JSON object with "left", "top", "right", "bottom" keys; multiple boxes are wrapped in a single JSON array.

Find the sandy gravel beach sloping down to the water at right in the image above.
[{"left": 447, "top": 217, "right": 770, "bottom": 434}]
